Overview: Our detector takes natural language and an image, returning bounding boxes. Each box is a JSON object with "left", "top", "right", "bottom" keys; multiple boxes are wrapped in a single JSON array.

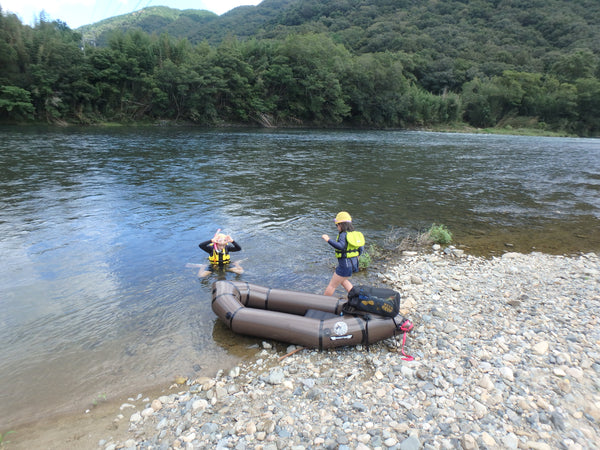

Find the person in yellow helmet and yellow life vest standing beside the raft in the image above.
[{"left": 321, "top": 211, "right": 364, "bottom": 295}]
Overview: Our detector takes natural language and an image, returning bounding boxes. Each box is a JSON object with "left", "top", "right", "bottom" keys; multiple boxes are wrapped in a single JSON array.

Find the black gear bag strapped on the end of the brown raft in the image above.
[{"left": 343, "top": 285, "right": 400, "bottom": 317}]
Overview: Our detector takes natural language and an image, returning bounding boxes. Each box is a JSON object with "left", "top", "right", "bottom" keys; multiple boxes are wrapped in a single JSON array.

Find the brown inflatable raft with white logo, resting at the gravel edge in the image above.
[{"left": 212, "top": 281, "right": 410, "bottom": 349}]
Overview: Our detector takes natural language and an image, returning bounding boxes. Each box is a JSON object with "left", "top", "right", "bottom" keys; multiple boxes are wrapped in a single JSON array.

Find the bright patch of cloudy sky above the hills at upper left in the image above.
[{"left": 0, "top": 0, "right": 261, "bottom": 29}]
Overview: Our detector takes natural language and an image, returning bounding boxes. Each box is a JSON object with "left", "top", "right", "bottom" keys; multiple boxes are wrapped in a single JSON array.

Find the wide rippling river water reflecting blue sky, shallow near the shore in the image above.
[{"left": 0, "top": 127, "right": 600, "bottom": 426}]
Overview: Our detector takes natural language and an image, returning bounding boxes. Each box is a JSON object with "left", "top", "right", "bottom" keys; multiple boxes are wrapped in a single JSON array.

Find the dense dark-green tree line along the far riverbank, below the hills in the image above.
[{"left": 0, "top": 10, "right": 600, "bottom": 136}]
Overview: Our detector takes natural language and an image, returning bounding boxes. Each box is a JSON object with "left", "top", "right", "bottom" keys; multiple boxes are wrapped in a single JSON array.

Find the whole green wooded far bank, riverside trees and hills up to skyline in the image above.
[{"left": 0, "top": 0, "right": 600, "bottom": 136}]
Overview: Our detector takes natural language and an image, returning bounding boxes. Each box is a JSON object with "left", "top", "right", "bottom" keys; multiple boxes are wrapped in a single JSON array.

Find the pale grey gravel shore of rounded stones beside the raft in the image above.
[{"left": 98, "top": 248, "right": 600, "bottom": 450}]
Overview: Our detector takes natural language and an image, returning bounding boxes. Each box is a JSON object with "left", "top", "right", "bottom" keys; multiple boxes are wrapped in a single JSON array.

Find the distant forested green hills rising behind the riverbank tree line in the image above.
[{"left": 77, "top": 0, "right": 600, "bottom": 70}]
